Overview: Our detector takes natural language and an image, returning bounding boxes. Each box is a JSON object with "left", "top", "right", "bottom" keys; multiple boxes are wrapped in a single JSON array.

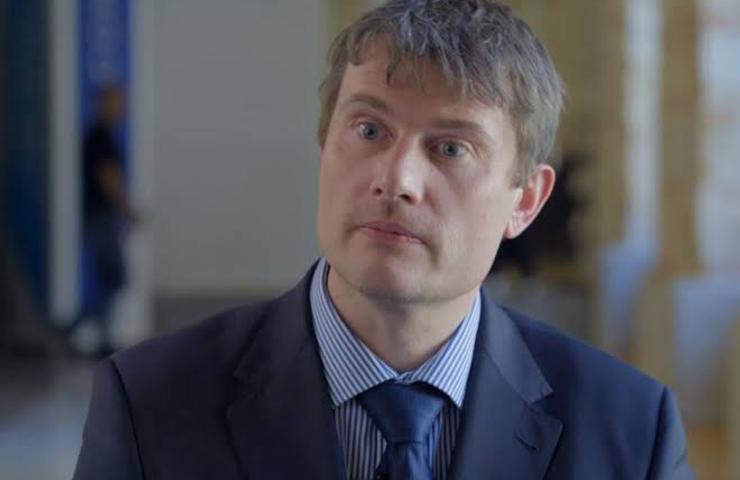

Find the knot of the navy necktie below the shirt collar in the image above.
[{"left": 359, "top": 382, "right": 445, "bottom": 444}]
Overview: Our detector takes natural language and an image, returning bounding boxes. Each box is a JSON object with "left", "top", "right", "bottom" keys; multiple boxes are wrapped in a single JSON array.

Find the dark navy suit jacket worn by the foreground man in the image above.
[{"left": 74, "top": 268, "right": 693, "bottom": 480}]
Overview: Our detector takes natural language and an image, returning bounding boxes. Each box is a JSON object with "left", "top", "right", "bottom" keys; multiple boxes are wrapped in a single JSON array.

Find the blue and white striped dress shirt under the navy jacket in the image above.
[{"left": 310, "top": 258, "right": 481, "bottom": 480}]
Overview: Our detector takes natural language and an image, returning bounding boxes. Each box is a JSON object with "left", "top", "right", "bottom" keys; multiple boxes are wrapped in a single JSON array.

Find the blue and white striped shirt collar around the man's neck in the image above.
[{"left": 310, "top": 258, "right": 481, "bottom": 408}]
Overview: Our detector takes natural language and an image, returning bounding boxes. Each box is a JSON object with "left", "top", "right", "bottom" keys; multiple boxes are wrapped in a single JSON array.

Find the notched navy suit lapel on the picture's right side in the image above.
[{"left": 450, "top": 295, "right": 562, "bottom": 480}]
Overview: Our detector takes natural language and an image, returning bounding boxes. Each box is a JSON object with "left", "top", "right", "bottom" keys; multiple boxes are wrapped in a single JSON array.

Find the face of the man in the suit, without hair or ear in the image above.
[{"left": 318, "top": 45, "right": 522, "bottom": 304}]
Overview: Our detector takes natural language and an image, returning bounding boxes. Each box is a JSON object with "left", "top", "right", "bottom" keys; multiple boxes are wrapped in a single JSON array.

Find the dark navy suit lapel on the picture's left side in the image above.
[{"left": 227, "top": 272, "right": 346, "bottom": 479}]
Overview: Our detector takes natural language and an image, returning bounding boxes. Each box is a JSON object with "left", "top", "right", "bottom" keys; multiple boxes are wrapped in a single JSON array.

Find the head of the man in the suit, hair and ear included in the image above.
[{"left": 318, "top": 0, "right": 563, "bottom": 302}]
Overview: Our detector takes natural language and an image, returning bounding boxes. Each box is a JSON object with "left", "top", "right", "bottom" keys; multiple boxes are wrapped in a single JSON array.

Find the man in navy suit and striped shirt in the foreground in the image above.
[{"left": 75, "top": 0, "right": 692, "bottom": 480}]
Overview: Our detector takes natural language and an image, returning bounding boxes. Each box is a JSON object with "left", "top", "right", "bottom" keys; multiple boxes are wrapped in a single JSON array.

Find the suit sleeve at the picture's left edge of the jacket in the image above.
[{"left": 73, "top": 359, "right": 144, "bottom": 480}]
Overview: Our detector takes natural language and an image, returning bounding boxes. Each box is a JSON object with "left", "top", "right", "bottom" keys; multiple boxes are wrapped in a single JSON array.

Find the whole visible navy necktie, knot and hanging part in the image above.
[{"left": 359, "top": 382, "right": 445, "bottom": 480}]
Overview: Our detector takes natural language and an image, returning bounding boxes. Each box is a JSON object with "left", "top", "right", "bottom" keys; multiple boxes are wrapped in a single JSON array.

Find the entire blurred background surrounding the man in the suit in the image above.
[{"left": 0, "top": 0, "right": 740, "bottom": 480}]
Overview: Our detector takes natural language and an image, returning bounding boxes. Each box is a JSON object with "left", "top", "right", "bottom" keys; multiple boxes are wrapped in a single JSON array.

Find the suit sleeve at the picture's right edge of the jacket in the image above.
[{"left": 647, "top": 388, "right": 694, "bottom": 480}]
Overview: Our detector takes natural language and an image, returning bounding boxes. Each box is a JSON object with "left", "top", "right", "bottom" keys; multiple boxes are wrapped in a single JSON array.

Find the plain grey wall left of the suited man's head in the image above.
[{"left": 144, "top": 0, "right": 328, "bottom": 296}]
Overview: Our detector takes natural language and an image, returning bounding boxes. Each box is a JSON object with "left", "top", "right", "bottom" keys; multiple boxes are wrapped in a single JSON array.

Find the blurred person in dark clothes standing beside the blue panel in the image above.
[{"left": 67, "top": 85, "right": 135, "bottom": 357}]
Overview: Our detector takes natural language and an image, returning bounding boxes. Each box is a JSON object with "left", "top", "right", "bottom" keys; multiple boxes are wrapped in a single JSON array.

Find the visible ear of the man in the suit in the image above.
[{"left": 504, "top": 165, "right": 555, "bottom": 239}]
